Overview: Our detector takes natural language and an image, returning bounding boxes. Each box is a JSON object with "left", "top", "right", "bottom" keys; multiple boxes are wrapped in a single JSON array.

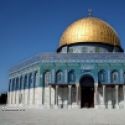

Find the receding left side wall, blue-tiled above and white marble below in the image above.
[{"left": 8, "top": 71, "right": 39, "bottom": 105}]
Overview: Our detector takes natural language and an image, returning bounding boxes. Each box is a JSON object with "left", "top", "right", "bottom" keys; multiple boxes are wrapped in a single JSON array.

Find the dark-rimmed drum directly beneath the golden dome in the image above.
[{"left": 57, "top": 42, "right": 123, "bottom": 53}]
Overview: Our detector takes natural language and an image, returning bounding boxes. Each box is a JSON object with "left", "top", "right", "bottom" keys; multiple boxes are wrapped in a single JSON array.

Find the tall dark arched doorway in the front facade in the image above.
[{"left": 80, "top": 75, "right": 94, "bottom": 108}]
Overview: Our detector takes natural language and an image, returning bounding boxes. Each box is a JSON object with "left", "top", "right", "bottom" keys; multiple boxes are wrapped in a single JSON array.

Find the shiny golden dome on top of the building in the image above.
[{"left": 60, "top": 17, "right": 120, "bottom": 46}]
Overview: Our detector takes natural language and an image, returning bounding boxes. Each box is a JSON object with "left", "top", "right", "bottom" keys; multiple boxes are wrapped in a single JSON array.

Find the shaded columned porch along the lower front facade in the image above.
[{"left": 49, "top": 78, "right": 125, "bottom": 109}]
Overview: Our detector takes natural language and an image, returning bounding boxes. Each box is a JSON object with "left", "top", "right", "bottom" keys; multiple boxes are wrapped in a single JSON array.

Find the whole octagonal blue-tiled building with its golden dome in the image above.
[{"left": 8, "top": 16, "right": 125, "bottom": 109}]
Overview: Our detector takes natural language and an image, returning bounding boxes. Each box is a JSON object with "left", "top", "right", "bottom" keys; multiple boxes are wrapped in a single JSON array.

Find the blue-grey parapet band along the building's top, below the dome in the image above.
[{"left": 9, "top": 52, "right": 125, "bottom": 72}]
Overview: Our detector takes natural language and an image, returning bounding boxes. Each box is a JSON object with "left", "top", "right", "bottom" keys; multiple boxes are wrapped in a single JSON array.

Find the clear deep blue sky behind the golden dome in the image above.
[{"left": 0, "top": 0, "right": 125, "bottom": 92}]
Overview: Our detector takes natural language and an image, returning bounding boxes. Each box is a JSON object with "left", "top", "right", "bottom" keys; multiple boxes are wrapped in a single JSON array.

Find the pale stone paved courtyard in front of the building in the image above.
[{"left": 0, "top": 106, "right": 125, "bottom": 125}]
